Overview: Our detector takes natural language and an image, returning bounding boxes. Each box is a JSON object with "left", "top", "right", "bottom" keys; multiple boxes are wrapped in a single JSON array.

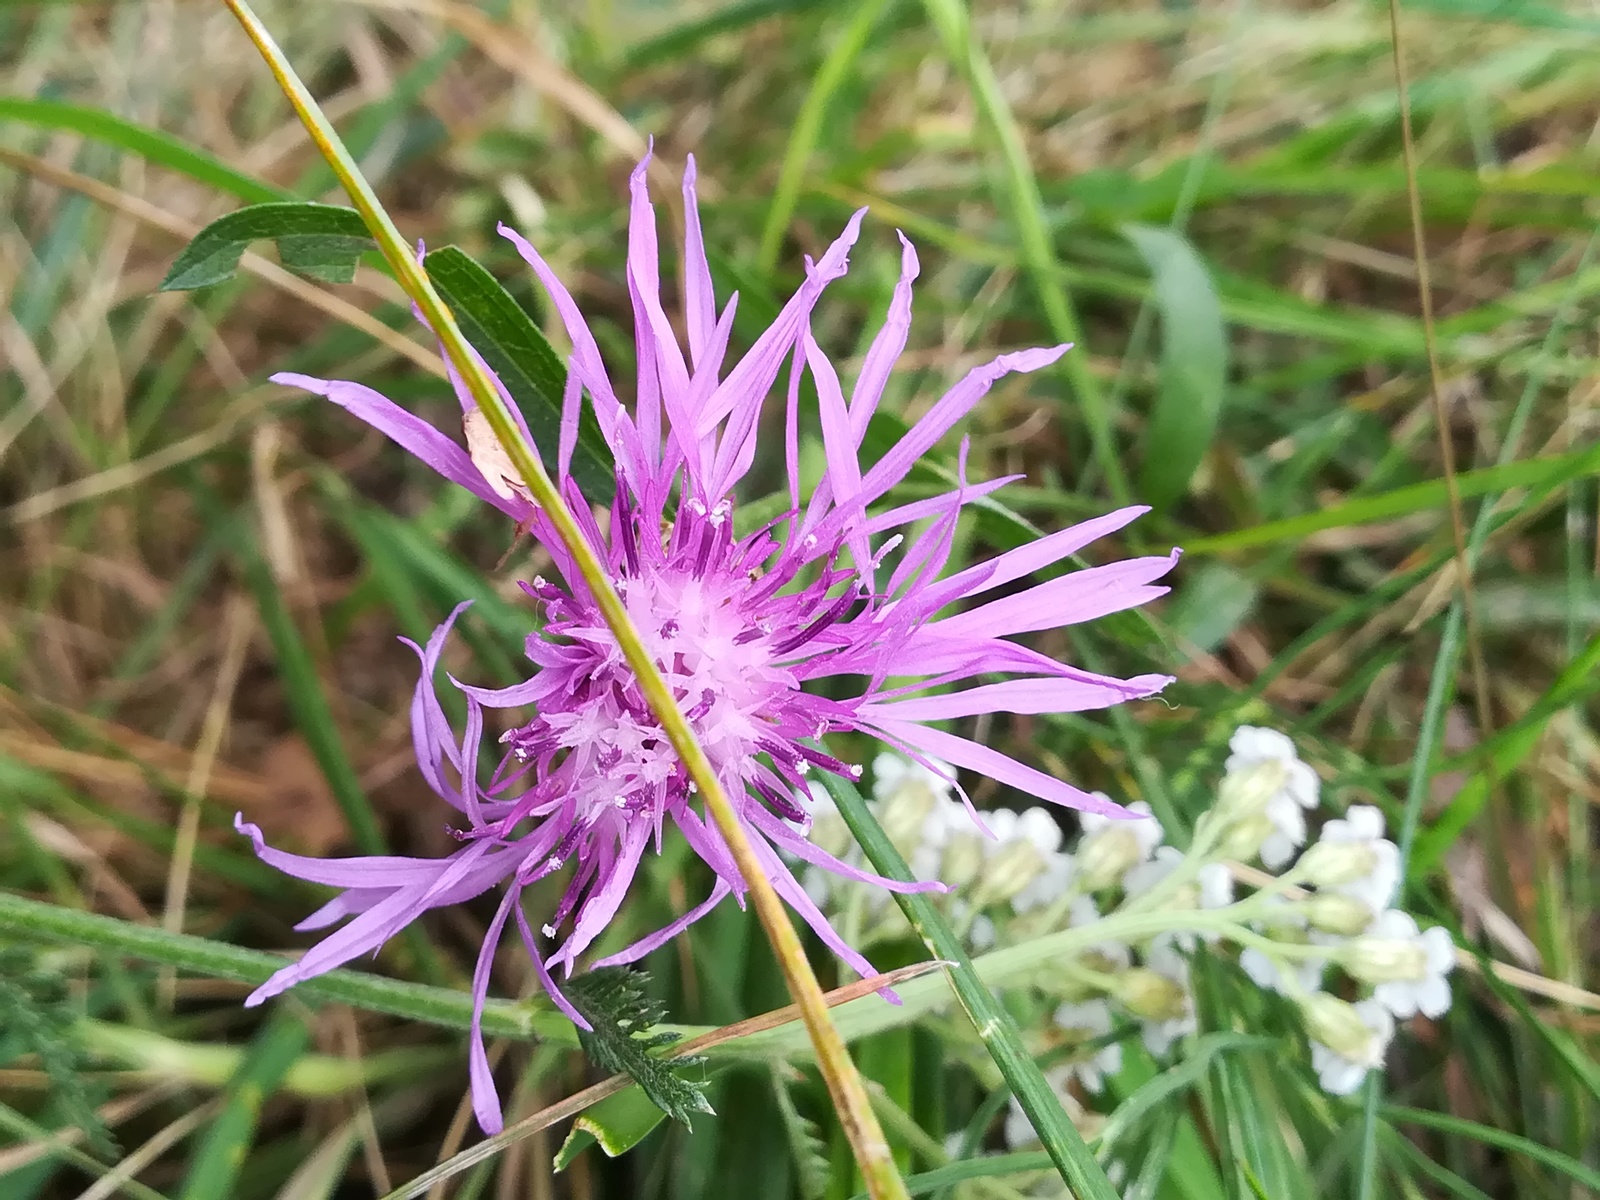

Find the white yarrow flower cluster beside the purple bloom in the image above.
[{"left": 806, "top": 726, "right": 1454, "bottom": 1186}]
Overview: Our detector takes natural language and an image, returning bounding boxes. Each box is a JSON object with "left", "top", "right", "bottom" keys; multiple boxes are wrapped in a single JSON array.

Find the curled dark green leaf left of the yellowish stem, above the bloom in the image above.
[{"left": 160, "top": 200, "right": 373, "bottom": 291}]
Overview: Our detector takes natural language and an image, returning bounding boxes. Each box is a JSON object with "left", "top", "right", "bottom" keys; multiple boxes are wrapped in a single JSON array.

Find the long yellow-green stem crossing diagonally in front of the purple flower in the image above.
[{"left": 224, "top": 0, "right": 907, "bottom": 1200}]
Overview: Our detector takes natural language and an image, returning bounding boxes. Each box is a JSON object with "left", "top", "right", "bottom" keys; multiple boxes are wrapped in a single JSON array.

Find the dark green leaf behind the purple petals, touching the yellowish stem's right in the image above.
[{"left": 422, "top": 246, "right": 616, "bottom": 502}]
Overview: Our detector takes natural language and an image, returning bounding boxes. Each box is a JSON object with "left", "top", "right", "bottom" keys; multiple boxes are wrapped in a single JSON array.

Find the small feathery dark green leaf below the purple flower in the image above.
[{"left": 566, "top": 966, "right": 712, "bottom": 1125}]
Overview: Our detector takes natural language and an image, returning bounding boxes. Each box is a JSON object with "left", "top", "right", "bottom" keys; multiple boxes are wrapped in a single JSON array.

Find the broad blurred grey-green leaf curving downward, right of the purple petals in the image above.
[{"left": 1122, "top": 224, "right": 1227, "bottom": 509}]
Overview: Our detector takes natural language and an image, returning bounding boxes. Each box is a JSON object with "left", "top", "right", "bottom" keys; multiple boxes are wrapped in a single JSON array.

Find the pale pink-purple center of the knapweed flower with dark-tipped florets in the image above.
[{"left": 499, "top": 501, "right": 858, "bottom": 827}]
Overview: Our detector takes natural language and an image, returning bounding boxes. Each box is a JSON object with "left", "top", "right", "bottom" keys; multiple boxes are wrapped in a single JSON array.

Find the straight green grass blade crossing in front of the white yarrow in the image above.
[{"left": 822, "top": 773, "right": 1117, "bottom": 1200}]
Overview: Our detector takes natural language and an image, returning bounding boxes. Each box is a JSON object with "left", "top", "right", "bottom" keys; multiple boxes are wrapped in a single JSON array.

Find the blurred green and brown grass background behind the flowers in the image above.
[{"left": 0, "top": 0, "right": 1600, "bottom": 1200}]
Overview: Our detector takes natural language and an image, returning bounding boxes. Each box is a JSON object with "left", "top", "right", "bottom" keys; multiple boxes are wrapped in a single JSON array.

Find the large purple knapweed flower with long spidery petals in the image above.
[{"left": 238, "top": 160, "right": 1176, "bottom": 1131}]
